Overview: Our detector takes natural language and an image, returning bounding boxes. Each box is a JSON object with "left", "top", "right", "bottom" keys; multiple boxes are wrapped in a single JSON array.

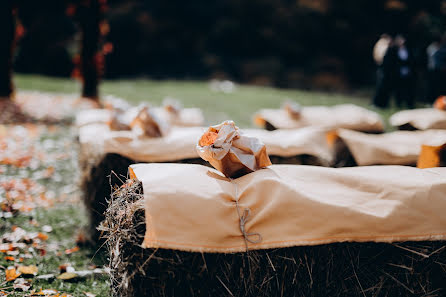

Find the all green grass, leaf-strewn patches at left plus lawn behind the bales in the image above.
[{"left": 0, "top": 75, "right": 412, "bottom": 296}]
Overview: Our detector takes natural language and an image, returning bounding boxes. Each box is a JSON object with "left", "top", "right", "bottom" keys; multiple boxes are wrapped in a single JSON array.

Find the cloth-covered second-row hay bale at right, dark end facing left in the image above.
[{"left": 327, "top": 129, "right": 446, "bottom": 167}]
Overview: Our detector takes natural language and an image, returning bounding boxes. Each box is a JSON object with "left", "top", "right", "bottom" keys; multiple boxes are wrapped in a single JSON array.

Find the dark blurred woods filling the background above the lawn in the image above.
[{"left": 9, "top": 0, "right": 446, "bottom": 90}]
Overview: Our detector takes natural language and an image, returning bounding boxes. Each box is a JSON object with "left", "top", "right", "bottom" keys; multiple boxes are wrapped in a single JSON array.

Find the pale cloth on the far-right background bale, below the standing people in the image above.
[{"left": 389, "top": 108, "right": 446, "bottom": 130}]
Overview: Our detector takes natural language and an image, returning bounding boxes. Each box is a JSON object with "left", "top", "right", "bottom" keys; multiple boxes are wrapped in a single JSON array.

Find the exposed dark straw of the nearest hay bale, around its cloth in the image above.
[{"left": 101, "top": 180, "right": 446, "bottom": 296}]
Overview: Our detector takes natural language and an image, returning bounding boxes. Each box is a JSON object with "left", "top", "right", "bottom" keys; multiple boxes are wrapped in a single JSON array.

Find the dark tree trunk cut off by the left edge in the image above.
[{"left": 0, "top": 0, "right": 15, "bottom": 100}]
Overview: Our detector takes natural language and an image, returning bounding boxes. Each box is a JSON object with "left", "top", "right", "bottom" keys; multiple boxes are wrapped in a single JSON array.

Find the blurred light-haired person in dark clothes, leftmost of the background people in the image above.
[{"left": 373, "top": 34, "right": 393, "bottom": 107}]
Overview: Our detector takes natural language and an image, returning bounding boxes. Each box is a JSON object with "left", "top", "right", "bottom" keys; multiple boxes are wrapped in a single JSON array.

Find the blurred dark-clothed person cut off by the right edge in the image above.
[{"left": 429, "top": 34, "right": 446, "bottom": 102}]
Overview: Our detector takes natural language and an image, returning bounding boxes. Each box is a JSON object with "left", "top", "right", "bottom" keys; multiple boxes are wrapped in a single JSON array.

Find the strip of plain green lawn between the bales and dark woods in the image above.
[{"left": 15, "top": 75, "right": 404, "bottom": 127}]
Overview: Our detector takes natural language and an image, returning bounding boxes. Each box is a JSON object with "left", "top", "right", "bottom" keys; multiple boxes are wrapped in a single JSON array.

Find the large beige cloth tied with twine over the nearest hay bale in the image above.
[{"left": 131, "top": 164, "right": 446, "bottom": 253}]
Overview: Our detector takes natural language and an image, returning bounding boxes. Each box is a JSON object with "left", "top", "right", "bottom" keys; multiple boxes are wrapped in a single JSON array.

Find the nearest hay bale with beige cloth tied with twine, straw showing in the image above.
[{"left": 101, "top": 164, "right": 446, "bottom": 296}]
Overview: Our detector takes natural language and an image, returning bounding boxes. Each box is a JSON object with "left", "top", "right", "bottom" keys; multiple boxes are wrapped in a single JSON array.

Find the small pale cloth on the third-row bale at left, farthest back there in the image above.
[{"left": 75, "top": 107, "right": 204, "bottom": 127}]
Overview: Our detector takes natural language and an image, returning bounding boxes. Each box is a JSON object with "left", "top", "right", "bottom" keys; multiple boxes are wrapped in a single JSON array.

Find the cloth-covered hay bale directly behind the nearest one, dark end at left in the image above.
[{"left": 79, "top": 118, "right": 333, "bottom": 241}]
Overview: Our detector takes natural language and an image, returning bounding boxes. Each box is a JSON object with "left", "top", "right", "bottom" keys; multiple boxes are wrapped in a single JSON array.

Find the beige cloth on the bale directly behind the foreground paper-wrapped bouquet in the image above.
[{"left": 79, "top": 124, "right": 333, "bottom": 165}]
